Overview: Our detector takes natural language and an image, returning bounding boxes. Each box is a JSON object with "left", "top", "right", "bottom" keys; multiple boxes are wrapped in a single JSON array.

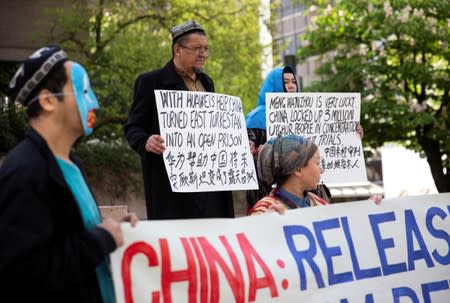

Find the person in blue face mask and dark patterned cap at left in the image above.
[{"left": 0, "top": 45, "right": 137, "bottom": 302}]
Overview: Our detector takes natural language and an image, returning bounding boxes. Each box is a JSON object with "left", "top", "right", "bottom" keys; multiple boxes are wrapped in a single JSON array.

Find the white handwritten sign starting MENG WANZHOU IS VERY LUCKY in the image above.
[{"left": 266, "top": 93, "right": 367, "bottom": 184}]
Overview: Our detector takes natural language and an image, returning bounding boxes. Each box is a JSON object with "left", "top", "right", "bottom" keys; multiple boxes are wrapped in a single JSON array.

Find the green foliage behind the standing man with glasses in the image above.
[{"left": 43, "top": 0, "right": 261, "bottom": 139}]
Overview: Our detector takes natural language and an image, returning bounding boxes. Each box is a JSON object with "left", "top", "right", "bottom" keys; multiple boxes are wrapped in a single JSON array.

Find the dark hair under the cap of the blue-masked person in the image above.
[{"left": 27, "top": 64, "right": 68, "bottom": 118}]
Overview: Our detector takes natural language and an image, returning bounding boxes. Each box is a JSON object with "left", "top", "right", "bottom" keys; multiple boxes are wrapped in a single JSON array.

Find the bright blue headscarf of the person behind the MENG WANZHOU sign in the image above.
[{"left": 246, "top": 65, "right": 299, "bottom": 130}]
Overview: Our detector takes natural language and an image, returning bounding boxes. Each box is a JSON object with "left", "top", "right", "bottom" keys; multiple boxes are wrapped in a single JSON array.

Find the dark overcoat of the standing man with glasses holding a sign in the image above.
[{"left": 125, "top": 60, "right": 234, "bottom": 219}]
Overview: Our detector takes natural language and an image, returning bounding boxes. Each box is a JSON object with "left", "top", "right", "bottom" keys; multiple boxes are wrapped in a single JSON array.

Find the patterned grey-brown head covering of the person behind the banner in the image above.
[{"left": 258, "top": 135, "right": 317, "bottom": 186}]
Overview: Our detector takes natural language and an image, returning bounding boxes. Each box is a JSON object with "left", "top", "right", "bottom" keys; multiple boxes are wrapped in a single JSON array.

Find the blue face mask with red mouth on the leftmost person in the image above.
[{"left": 71, "top": 62, "right": 99, "bottom": 136}]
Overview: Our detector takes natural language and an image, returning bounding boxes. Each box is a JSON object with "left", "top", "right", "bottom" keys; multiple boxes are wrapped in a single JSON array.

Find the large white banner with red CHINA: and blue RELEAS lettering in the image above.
[{"left": 111, "top": 193, "right": 450, "bottom": 303}]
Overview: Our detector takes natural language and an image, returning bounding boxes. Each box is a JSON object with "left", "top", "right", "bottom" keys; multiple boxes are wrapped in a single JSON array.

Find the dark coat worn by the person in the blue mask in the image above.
[{"left": 0, "top": 128, "right": 116, "bottom": 303}]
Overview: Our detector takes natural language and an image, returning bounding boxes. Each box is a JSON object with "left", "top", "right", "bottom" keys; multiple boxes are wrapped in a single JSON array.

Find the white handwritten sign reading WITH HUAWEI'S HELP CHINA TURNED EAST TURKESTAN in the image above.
[{"left": 155, "top": 90, "right": 258, "bottom": 192}]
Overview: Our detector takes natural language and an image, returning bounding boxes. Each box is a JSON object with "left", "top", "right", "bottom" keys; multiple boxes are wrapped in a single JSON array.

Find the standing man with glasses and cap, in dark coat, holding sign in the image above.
[{"left": 125, "top": 21, "right": 234, "bottom": 219}]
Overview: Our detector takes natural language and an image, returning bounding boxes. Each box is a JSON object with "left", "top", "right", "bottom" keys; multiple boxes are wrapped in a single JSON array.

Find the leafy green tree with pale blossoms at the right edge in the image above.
[{"left": 298, "top": 0, "right": 450, "bottom": 191}]
